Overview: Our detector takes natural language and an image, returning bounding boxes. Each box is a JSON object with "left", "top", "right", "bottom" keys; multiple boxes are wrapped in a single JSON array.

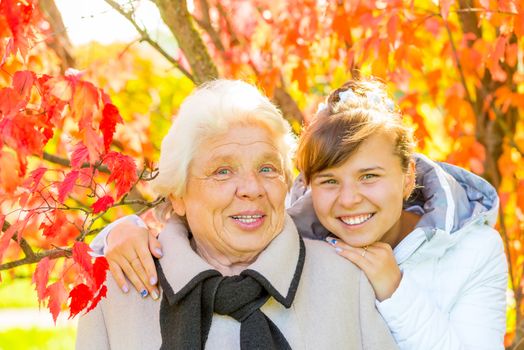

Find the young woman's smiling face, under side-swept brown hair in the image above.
[{"left": 311, "top": 133, "right": 414, "bottom": 247}]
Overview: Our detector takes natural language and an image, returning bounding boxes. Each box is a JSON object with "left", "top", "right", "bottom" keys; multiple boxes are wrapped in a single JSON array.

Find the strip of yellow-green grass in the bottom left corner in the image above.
[{"left": 0, "top": 327, "right": 76, "bottom": 350}]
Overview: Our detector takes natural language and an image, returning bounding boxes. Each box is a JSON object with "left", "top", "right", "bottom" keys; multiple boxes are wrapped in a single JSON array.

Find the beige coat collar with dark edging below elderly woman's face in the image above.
[{"left": 158, "top": 215, "right": 305, "bottom": 307}]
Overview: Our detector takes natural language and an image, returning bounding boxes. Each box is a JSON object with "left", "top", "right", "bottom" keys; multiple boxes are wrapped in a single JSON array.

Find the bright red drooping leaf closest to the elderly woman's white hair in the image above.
[{"left": 104, "top": 152, "right": 138, "bottom": 198}]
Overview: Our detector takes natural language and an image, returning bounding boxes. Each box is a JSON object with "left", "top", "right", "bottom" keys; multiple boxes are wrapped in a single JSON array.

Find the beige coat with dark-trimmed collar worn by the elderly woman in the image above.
[{"left": 77, "top": 217, "right": 397, "bottom": 350}]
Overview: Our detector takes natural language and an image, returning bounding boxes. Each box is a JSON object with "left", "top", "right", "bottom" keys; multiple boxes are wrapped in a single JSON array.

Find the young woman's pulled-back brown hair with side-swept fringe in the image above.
[{"left": 296, "top": 79, "right": 415, "bottom": 184}]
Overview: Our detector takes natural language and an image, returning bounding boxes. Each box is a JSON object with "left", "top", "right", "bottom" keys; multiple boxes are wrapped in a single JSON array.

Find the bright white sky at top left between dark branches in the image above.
[{"left": 55, "top": 0, "right": 166, "bottom": 45}]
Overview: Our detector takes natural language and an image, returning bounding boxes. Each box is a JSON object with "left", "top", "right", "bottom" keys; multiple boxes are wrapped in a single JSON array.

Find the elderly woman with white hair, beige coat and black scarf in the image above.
[{"left": 77, "top": 80, "right": 396, "bottom": 350}]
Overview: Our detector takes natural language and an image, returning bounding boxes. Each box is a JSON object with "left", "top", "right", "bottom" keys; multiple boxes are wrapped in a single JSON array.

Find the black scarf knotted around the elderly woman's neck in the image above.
[{"left": 155, "top": 238, "right": 305, "bottom": 350}]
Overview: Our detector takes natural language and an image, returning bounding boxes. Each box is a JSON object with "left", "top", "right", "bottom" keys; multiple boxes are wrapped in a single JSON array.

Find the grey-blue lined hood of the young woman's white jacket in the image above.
[{"left": 287, "top": 154, "right": 499, "bottom": 240}]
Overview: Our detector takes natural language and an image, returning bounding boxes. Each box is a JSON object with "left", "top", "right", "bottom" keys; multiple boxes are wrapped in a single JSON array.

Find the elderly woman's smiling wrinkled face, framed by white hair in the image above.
[{"left": 173, "top": 126, "right": 288, "bottom": 262}]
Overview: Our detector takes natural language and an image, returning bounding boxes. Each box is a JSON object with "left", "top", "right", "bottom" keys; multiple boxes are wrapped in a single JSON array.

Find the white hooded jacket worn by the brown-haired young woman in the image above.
[{"left": 288, "top": 155, "right": 507, "bottom": 350}]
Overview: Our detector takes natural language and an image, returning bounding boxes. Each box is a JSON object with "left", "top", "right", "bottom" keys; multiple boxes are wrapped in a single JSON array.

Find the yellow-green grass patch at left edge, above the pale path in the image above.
[{"left": 0, "top": 278, "right": 38, "bottom": 308}]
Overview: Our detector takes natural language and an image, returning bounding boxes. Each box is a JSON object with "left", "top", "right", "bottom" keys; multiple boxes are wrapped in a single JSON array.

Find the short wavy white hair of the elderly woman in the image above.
[{"left": 152, "top": 79, "right": 296, "bottom": 196}]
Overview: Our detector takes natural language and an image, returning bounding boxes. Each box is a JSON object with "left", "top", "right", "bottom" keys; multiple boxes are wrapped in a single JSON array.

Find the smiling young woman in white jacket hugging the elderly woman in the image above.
[{"left": 91, "top": 80, "right": 507, "bottom": 350}]
